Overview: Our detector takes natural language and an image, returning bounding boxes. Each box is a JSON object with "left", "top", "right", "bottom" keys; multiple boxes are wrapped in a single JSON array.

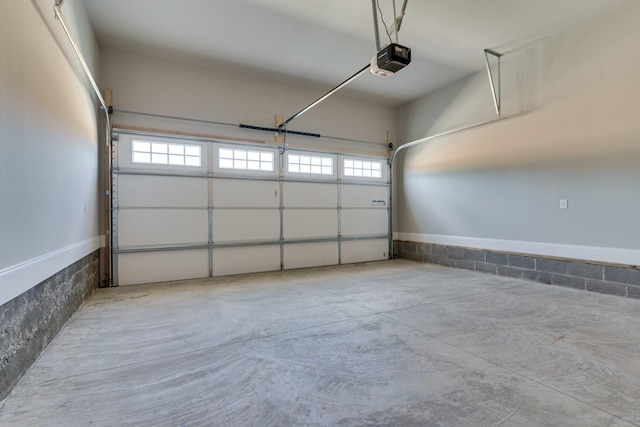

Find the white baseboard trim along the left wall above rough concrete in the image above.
[{"left": 0, "top": 236, "right": 103, "bottom": 305}]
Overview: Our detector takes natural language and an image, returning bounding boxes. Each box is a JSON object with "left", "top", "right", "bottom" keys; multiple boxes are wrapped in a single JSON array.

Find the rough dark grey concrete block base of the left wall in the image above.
[{"left": 0, "top": 251, "right": 100, "bottom": 400}]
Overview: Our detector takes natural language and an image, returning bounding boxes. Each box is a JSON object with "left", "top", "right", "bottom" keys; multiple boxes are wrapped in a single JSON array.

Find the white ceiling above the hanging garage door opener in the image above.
[{"left": 84, "top": 0, "right": 633, "bottom": 106}]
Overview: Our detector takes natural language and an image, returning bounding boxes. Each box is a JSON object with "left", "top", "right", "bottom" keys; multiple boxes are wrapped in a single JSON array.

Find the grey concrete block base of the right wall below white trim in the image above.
[{"left": 393, "top": 240, "right": 640, "bottom": 299}]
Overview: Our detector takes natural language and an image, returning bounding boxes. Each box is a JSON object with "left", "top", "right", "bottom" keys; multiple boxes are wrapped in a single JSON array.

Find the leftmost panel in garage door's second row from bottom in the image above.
[{"left": 118, "top": 209, "right": 209, "bottom": 248}]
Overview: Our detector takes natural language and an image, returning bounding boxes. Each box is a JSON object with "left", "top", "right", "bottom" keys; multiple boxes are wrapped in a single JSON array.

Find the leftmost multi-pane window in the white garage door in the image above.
[{"left": 131, "top": 140, "right": 202, "bottom": 167}]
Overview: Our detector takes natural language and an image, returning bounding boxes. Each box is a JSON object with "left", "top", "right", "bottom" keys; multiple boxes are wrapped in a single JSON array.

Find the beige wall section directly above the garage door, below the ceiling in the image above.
[{"left": 101, "top": 49, "right": 395, "bottom": 153}]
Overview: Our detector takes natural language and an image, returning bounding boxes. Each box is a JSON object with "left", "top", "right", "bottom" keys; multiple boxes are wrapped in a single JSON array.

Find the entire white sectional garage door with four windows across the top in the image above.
[{"left": 113, "top": 131, "right": 390, "bottom": 285}]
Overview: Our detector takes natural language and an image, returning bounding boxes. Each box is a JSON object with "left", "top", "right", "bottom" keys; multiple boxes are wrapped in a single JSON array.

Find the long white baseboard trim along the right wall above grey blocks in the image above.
[{"left": 393, "top": 232, "right": 640, "bottom": 266}]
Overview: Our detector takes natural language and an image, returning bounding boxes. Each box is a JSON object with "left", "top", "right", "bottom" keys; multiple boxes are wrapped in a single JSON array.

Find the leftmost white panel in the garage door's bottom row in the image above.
[{"left": 118, "top": 250, "right": 209, "bottom": 285}]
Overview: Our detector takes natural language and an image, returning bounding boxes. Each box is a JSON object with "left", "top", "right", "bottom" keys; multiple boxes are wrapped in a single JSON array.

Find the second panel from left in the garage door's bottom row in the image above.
[{"left": 213, "top": 246, "right": 280, "bottom": 276}]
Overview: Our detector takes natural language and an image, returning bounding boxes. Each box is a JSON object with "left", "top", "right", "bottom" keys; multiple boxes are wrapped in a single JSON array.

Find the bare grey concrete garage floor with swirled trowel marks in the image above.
[{"left": 0, "top": 260, "right": 640, "bottom": 427}]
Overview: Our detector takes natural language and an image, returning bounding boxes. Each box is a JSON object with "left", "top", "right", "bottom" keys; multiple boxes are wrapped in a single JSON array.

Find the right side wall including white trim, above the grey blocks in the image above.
[{"left": 394, "top": 3, "right": 640, "bottom": 264}]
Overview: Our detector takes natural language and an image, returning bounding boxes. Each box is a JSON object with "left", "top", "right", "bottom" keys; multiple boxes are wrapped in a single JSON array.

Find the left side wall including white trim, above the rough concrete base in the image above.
[{"left": 0, "top": 0, "right": 102, "bottom": 304}]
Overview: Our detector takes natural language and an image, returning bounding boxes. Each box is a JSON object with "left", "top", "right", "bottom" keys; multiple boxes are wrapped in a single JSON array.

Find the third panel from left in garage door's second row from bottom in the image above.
[{"left": 284, "top": 209, "right": 338, "bottom": 239}]
